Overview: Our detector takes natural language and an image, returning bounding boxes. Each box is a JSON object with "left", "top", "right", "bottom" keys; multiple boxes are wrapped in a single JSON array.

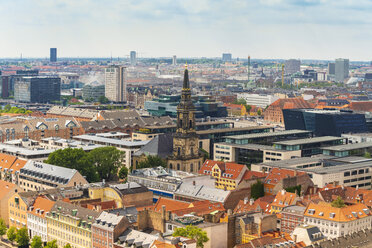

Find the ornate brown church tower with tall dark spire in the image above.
[{"left": 168, "top": 66, "right": 203, "bottom": 173}]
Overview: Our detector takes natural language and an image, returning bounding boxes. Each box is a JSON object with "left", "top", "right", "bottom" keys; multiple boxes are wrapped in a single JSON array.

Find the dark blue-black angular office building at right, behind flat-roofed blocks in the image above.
[{"left": 283, "top": 109, "right": 368, "bottom": 136}]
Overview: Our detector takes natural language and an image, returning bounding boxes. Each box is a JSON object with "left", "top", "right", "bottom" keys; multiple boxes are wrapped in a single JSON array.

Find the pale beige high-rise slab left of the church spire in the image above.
[{"left": 105, "top": 65, "right": 127, "bottom": 102}]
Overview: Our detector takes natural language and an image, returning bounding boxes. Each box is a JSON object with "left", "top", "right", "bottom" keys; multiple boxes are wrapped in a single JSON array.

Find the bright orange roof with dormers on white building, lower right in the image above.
[{"left": 304, "top": 202, "right": 371, "bottom": 222}]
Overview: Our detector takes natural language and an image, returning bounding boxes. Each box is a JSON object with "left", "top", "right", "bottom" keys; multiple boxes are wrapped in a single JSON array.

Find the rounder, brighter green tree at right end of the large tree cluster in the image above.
[{"left": 88, "top": 146, "right": 124, "bottom": 181}]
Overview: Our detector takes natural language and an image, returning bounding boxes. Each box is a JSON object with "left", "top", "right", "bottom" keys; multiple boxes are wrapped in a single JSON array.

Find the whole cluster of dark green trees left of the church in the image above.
[{"left": 45, "top": 147, "right": 124, "bottom": 182}]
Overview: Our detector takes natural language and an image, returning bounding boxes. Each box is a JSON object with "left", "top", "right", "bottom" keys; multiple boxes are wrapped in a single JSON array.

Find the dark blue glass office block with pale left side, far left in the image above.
[{"left": 14, "top": 76, "right": 61, "bottom": 103}]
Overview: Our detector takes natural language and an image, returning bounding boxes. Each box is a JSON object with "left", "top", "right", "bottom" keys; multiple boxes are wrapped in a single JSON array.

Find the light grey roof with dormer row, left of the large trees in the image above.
[{"left": 20, "top": 160, "right": 78, "bottom": 184}]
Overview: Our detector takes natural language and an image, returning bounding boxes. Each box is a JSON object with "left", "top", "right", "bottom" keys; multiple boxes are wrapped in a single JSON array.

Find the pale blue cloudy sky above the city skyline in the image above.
[{"left": 0, "top": 0, "right": 372, "bottom": 61}]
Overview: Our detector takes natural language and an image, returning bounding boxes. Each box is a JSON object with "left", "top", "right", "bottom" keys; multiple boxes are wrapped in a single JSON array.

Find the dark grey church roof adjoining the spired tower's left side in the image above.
[{"left": 134, "top": 134, "right": 173, "bottom": 158}]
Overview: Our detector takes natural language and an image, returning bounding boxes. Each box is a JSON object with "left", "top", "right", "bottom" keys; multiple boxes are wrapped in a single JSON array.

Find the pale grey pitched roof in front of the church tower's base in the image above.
[{"left": 175, "top": 183, "right": 230, "bottom": 203}]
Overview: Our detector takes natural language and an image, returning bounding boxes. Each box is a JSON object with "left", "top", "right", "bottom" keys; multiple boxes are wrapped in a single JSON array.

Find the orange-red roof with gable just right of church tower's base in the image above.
[{"left": 199, "top": 159, "right": 247, "bottom": 179}]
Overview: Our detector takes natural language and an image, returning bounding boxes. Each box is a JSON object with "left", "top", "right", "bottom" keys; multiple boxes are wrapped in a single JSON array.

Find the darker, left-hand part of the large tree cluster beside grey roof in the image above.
[{"left": 45, "top": 148, "right": 100, "bottom": 182}]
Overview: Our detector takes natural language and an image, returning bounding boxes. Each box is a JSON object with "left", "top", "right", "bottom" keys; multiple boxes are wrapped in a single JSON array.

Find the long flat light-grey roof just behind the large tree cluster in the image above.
[{"left": 74, "top": 134, "right": 150, "bottom": 148}]
